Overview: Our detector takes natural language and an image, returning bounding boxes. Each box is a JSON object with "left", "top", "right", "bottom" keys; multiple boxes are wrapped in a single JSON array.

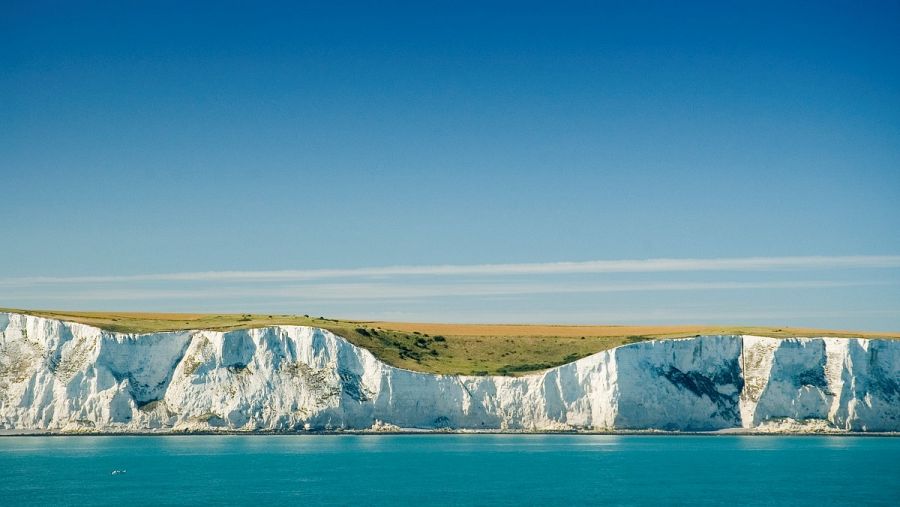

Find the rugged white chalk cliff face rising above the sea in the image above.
[{"left": 0, "top": 313, "right": 900, "bottom": 432}]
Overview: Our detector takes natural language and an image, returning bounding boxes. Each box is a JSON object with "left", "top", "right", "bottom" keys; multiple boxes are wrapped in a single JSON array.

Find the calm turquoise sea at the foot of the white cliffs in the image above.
[{"left": 0, "top": 435, "right": 900, "bottom": 506}]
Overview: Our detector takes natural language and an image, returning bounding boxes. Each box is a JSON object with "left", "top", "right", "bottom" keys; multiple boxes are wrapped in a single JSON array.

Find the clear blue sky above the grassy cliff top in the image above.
[{"left": 0, "top": 2, "right": 900, "bottom": 329}]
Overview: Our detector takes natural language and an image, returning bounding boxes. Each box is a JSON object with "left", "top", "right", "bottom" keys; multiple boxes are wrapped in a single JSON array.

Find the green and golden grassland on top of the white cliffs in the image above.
[{"left": 0, "top": 309, "right": 900, "bottom": 375}]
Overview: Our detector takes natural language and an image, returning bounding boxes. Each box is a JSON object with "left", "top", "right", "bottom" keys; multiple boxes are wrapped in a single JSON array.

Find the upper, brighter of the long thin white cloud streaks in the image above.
[{"left": 0, "top": 255, "right": 900, "bottom": 286}]
